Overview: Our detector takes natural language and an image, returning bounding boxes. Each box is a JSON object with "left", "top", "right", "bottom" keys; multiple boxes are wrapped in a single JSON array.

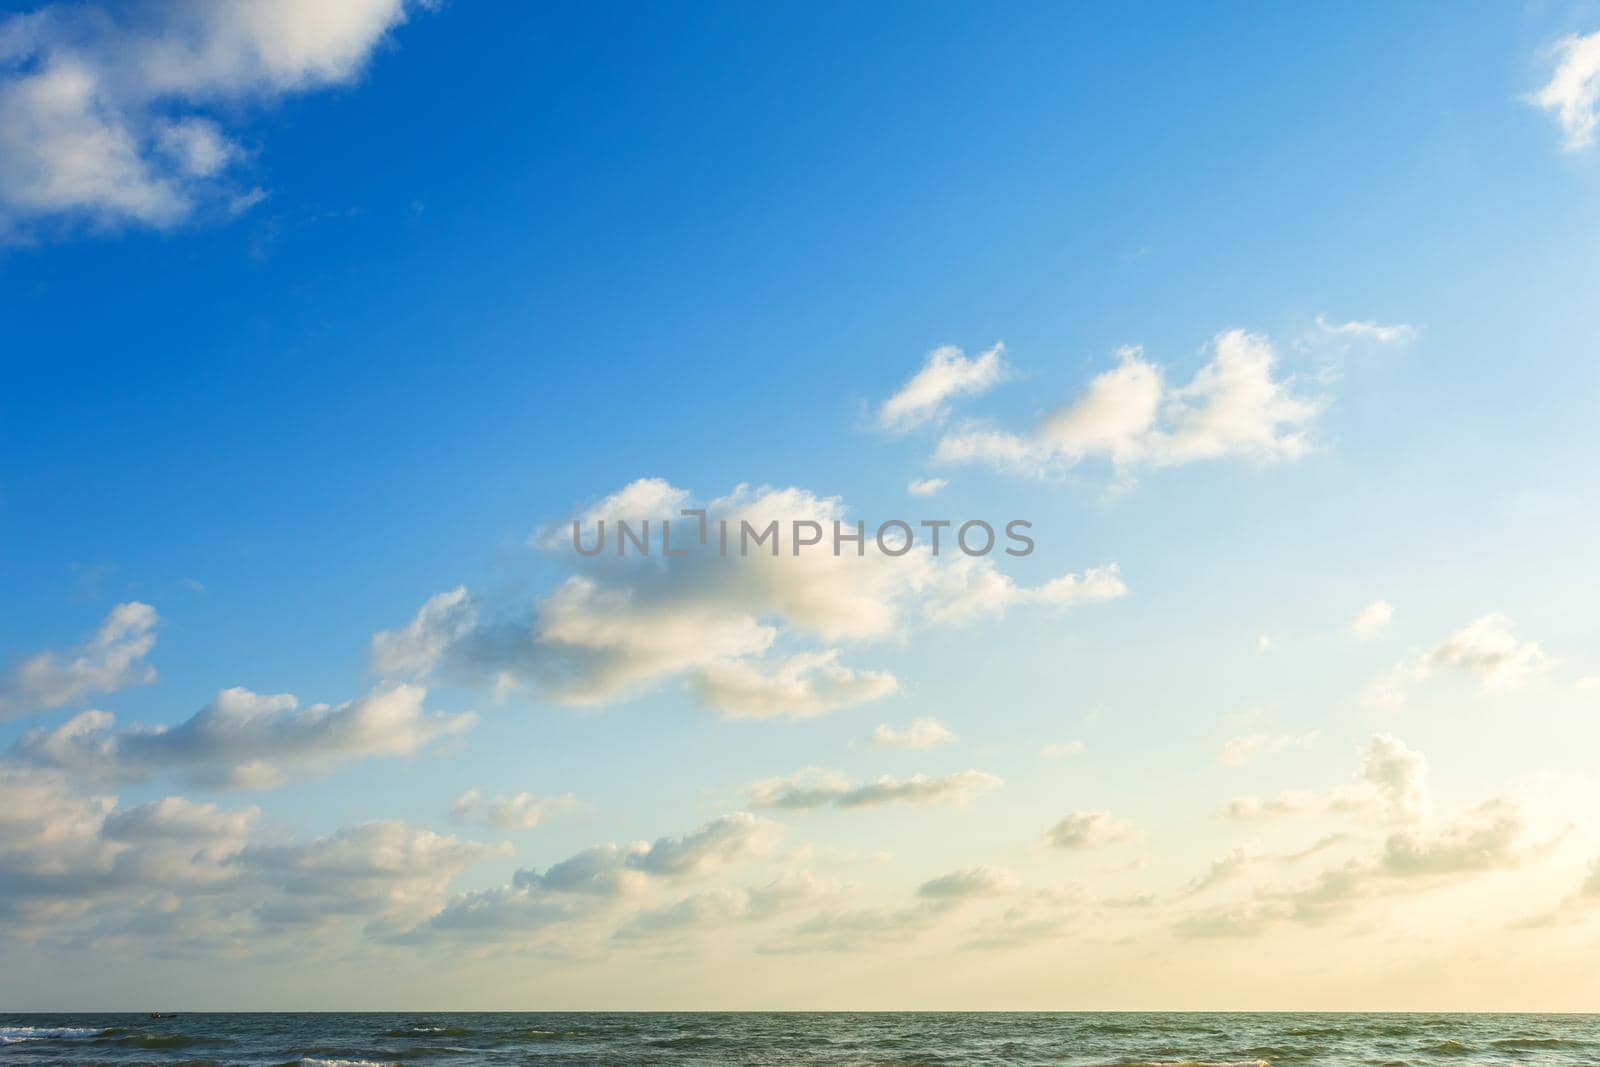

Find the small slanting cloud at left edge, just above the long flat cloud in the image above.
[{"left": 0, "top": 604, "right": 157, "bottom": 721}]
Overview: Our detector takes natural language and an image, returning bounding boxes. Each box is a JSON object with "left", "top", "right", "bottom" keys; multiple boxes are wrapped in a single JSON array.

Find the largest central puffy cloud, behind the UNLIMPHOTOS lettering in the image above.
[{"left": 371, "top": 478, "right": 1126, "bottom": 717}]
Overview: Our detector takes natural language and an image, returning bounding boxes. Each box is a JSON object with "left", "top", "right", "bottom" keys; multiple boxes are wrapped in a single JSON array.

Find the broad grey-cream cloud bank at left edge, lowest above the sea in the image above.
[{"left": 0, "top": 766, "right": 502, "bottom": 950}]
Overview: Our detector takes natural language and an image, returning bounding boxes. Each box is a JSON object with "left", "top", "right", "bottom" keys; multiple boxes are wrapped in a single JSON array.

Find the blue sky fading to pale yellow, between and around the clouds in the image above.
[{"left": 0, "top": 0, "right": 1600, "bottom": 1008}]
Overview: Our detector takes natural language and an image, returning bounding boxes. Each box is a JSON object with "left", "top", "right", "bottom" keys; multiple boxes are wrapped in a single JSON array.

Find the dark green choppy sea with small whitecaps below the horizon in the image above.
[{"left": 0, "top": 1013, "right": 1600, "bottom": 1067}]
